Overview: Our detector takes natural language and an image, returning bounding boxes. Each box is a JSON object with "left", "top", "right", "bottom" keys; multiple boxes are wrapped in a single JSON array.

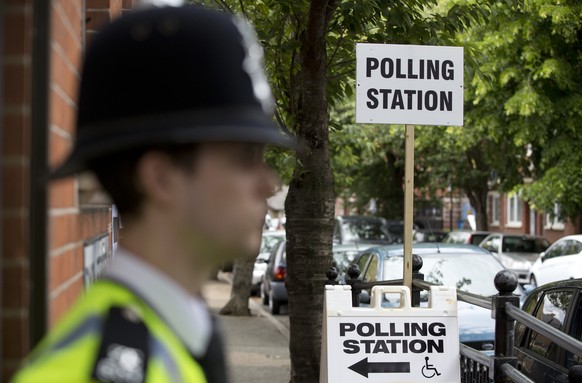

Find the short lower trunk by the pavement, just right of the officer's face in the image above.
[{"left": 220, "top": 258, "right": 255, "bottom": 316}]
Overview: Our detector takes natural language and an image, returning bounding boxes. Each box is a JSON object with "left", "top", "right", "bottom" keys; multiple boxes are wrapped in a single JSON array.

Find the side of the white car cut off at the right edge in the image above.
[{"left": 540, "top": 239, "right": 582, "bottom": 284}]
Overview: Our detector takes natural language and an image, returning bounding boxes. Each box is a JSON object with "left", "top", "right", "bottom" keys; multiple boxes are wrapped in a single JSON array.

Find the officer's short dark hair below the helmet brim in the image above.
[{"left": 89, "top": 144, "right": 196, "bottom": 220}]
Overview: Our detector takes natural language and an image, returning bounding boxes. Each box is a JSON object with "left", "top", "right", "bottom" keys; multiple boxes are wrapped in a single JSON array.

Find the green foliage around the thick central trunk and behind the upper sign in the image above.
[{"left": 195, "top": 0, "right": 488, "bottom": 218}]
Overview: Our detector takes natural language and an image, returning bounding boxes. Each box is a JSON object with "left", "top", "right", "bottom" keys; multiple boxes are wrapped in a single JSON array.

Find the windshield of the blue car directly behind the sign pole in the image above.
[{"left": 383, "top": 253, "right": 503, "bottom": 297}]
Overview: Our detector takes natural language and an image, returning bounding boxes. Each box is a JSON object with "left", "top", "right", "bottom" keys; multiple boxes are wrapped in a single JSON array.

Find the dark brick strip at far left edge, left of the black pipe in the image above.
[{"left": 0, "top": 0, "right": 32, "bottom": 381}]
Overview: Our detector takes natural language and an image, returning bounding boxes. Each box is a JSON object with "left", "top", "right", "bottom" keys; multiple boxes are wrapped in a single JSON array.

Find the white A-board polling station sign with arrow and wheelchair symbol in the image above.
[{"left": 320, "top": 285, "right": 461, "bottom": 383}]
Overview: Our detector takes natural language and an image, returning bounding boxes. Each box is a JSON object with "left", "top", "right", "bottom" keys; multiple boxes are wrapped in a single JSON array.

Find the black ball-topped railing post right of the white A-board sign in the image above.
[{"left": 489, "top": 270, "right": 519, "bottom": 383}]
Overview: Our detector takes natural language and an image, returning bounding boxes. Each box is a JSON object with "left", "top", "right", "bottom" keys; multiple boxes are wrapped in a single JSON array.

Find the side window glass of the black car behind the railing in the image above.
[{"left": 528, "top": 290, "right": 574, "bottom": 364}]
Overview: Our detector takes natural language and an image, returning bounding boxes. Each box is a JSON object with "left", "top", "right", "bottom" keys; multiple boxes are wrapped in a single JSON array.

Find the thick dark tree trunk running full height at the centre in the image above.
[{"left": 285, "top": 0, "right": 335, "bottom": 383}]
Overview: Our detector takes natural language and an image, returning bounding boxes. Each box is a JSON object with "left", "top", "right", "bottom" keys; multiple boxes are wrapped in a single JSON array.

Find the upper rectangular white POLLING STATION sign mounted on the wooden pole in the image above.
[{"left": 356, "top": 43, "right": 463, "bottom": 126}]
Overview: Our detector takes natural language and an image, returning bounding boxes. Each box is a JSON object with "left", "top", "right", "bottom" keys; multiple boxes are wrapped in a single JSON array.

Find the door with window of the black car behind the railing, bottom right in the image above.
[{"left": 515, "top": 288, "right": 580, "bottom": 383}]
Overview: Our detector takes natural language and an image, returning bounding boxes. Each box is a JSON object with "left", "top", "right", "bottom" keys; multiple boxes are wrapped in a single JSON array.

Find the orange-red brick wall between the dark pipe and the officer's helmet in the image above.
[{"left": 47, "top": 0, "right": 85, "bottom": 326}]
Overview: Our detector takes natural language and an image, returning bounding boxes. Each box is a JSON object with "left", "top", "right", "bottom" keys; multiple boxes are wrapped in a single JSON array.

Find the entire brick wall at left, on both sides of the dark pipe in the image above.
[{"left": 0, "top": 0, "right": 133, "bottom": 382}]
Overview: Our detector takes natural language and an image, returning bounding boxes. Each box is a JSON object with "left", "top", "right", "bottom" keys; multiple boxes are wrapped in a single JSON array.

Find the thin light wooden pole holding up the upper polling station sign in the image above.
[{"left": 403, "top": 124, "right": 414, "bottom": 291}]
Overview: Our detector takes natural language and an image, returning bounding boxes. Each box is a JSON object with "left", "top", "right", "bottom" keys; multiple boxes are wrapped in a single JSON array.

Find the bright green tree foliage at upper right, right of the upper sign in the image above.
[{"left": 467, "top": 0, "right": 582, "bottom": 219}]
